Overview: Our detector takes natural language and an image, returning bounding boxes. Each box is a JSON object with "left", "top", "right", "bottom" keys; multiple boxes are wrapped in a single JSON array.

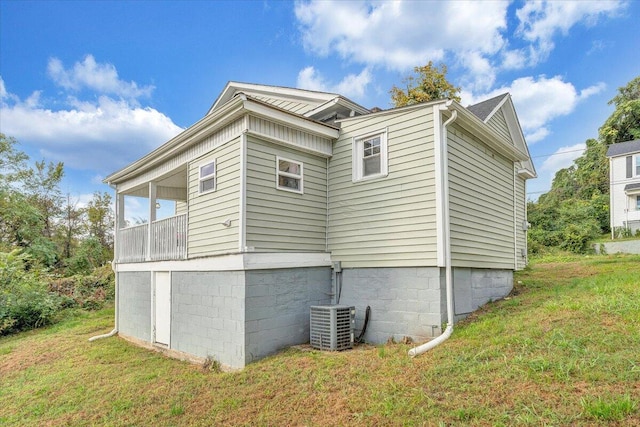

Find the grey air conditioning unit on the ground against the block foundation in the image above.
[{"left": 310, "top": 305, "right": 356, "bottom": 351}]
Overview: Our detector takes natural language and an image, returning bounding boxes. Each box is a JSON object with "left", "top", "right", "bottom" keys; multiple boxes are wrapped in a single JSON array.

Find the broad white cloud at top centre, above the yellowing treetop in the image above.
[{"left": 295, "top": 1, "right": 508, "bottom": 74}]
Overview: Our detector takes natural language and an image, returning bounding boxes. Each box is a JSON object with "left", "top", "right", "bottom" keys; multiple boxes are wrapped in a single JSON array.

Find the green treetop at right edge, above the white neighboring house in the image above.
[{"left": 600, "top": 76, "right": 640, "bottom": 145}]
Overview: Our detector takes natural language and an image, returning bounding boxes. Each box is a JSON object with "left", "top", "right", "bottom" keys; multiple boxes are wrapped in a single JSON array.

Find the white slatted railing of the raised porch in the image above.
[{"left": 117, "top": 214, "right": 187, "bottom": 262}]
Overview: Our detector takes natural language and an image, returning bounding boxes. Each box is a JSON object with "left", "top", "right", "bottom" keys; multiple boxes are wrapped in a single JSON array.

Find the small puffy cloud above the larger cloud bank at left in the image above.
[{"left": 47, "top": 55, "right": 154, "bottom": 99}]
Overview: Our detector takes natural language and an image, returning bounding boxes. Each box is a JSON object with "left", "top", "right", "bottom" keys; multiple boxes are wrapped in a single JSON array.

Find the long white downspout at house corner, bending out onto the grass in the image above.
[{"left": 409, "top": 106, "right": 458, "bottom": 357}]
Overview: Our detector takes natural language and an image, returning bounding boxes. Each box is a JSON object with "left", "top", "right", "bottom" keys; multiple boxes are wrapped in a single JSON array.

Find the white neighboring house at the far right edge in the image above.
[{"left": 607, "top": 139, "right": 640, "bottom": 237}]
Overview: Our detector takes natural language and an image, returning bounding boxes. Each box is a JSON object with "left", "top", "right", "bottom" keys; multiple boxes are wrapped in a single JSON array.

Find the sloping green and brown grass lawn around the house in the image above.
[{"left": 0, "top": 256, "right": 640, "bottom": 426}]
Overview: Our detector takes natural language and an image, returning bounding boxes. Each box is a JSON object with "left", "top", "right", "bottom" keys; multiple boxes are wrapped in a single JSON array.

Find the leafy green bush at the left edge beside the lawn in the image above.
[{"left": 0, "top": 250, "right": 61, "bottom": 335}]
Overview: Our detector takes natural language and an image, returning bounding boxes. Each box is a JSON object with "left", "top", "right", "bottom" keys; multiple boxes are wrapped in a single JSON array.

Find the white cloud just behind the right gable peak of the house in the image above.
[{"left": 462, "top": 76, "right": 604, "bottom": 144}]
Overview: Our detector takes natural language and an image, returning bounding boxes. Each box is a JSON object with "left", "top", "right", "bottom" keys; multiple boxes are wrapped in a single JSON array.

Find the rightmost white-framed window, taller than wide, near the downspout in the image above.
[{"left": 353, "top": 132, "right": 388, "bottom": 181}]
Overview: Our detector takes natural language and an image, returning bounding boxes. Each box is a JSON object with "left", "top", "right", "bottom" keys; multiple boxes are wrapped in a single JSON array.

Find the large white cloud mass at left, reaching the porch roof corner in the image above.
[{"left": 0, "top": 56, "right": 182, "bottom": 174}]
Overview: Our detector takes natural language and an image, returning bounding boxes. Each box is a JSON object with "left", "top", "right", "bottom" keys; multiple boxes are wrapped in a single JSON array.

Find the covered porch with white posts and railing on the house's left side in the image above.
[{"left": 115, "top": 165, "right": 188, "bottom": 263}]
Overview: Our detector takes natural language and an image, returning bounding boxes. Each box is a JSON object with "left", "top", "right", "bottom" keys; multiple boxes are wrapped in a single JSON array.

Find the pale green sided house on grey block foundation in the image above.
[{"left": 105, "top": 82, "right": 536, "bottom": 367}]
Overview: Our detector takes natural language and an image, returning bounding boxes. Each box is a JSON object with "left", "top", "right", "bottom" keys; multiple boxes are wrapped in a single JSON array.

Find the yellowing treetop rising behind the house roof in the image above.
[{"left": 389, "top": 61, "right": 460, "bottom": 107}]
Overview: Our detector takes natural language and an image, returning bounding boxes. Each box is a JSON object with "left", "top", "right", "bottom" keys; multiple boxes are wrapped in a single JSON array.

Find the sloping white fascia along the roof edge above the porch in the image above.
[{"left": 103, "top": 97, "right": 245, "bottom": 184}]
